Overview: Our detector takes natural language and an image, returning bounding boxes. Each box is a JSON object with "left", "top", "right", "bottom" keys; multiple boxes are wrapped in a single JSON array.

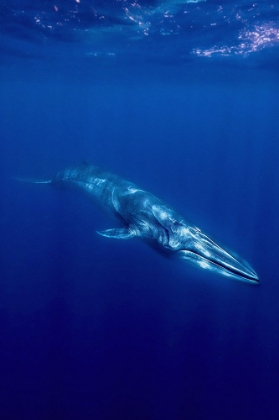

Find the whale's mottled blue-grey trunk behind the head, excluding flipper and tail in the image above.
[{"left": 53, "top": 164, "right": 187, "bottom": 251}]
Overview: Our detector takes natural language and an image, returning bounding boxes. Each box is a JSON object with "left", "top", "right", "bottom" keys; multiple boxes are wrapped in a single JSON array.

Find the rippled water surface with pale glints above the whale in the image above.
[{"left": 0, "top": 0, "right": 279, "bottom": 68}]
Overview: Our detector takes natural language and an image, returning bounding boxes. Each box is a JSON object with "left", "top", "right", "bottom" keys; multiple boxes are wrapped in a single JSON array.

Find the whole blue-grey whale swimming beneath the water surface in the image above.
[{"left": 26, "top": 163, "right": 259, "bottom": 284}]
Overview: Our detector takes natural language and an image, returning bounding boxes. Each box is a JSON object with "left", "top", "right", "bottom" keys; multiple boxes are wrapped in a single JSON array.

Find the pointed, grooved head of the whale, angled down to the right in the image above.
[{"left": 173, "top": 226, "right": 259, "bottom": 284}]
